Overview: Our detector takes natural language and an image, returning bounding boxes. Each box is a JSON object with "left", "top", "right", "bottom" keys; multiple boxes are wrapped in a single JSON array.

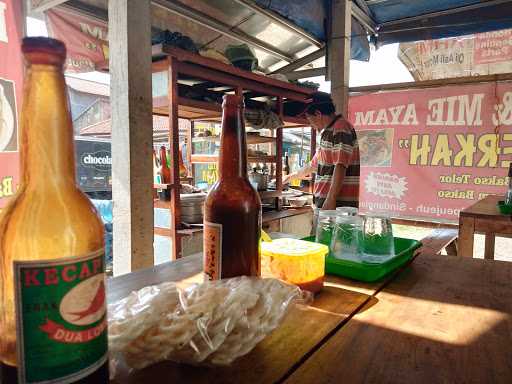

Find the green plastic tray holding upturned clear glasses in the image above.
[{"left": 303, "top": 236, "right": 421, "bottom": 282}]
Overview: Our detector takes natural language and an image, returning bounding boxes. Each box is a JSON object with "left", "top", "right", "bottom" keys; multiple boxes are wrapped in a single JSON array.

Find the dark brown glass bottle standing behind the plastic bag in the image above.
[{"left": 203, "top": 95, "right": 261, "bottom": 280}]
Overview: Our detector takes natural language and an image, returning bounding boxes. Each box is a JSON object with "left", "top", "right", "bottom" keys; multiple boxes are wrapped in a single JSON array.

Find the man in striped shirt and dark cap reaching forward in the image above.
[{"left": 283, "top": 92, "right": 359, "bottom": 209}]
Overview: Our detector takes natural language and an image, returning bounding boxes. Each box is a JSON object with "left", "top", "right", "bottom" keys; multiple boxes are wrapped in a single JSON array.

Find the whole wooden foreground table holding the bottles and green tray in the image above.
[{"left": 108, "top": 254, "right": 512, "bottom": 383}]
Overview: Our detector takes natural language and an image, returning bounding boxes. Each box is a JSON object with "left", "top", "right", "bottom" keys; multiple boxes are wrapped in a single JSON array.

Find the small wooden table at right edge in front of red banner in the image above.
[{"left": 458, "top": 195, "right": 512, "bottom": 260}]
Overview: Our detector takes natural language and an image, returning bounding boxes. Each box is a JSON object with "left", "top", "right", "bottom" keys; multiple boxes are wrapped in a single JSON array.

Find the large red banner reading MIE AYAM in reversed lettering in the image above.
[{"left": 349, "top": 82, "right": 512, "bottom": 221}]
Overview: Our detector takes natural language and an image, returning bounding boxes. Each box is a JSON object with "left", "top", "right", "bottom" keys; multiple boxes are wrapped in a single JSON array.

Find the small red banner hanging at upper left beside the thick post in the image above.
[{"left": 46, "top": 8, "right": 108, "bottom": 72}]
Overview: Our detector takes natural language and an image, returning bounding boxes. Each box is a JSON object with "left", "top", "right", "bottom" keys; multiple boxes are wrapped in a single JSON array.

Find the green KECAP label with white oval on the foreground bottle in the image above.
[{"left": 14, "top": 250, "right": 108, "bottom": 384}]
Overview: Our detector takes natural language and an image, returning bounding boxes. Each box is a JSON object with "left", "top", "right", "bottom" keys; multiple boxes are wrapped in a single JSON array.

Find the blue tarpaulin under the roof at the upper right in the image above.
[{"left": 251, "top": 0, "right": 512, "bottom": 60}]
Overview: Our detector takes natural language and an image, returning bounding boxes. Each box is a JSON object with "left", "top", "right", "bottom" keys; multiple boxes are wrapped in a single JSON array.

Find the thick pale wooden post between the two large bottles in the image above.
[{"left": 108, "top": 0, "right": 154, "bottom": 275}]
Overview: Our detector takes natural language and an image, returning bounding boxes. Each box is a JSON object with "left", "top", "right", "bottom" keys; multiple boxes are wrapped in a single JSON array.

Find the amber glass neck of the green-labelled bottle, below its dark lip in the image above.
[{"left": 20, "top": 64, "right": 75, "bottom": 188}]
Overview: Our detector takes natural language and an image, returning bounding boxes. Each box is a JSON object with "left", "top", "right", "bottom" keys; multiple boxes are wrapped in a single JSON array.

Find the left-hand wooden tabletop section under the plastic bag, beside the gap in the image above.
[{"left": 108, "top": 254, "right": 386, "bottom": 383}]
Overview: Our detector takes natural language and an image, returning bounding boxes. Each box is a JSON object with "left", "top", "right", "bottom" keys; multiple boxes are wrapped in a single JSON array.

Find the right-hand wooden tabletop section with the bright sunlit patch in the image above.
[{"left": 286, "top": 255, "right": 512, "bottom": 384}]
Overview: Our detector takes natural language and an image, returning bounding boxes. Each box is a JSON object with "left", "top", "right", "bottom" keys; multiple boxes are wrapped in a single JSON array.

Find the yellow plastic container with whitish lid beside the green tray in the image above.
[{"left": 261, "top": 239, "right": 329, "bottom": 292}]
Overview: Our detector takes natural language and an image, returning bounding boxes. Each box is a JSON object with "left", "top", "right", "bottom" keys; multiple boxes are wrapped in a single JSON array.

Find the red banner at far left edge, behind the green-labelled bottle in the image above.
[{"left": 0, "top": 0, "right": 23, "bottom": 208}]
